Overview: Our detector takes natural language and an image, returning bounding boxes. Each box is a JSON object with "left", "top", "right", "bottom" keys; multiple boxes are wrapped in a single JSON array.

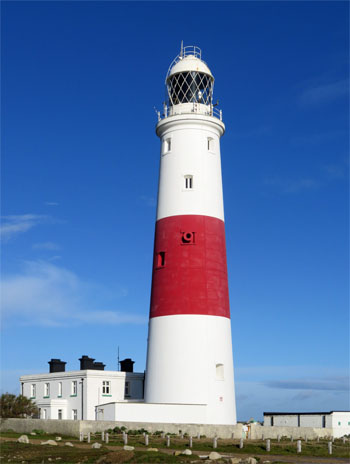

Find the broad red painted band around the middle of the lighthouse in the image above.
[{"left": 150, "top": 215, "right": 230, "bottom": 318}]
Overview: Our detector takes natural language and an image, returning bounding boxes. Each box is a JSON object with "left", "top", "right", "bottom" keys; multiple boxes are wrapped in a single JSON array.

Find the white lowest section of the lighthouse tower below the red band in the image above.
[{"left": 145, "top": 314, "right": 236, "bottom": 424}]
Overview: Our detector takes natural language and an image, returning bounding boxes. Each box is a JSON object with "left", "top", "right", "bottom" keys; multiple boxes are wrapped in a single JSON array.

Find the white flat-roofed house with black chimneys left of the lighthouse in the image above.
[{"left": 20, "top": 355, "right": 145, "bottom": 420}]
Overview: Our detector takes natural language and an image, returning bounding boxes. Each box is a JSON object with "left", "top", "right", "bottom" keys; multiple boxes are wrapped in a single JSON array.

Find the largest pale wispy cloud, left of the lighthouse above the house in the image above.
[{"left": 2, "top": 261, "right": 146, "bottom": 327}]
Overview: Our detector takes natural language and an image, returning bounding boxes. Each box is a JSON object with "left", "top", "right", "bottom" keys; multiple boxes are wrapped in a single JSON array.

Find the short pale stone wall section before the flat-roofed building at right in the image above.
[{"left": 249, "top": 424, "right": 333, "bottom": 440}]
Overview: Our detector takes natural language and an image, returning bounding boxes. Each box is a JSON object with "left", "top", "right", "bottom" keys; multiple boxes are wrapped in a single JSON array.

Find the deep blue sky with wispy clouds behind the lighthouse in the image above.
[{"left": 1, "top": 2, "right": 349, "bottom": 420}]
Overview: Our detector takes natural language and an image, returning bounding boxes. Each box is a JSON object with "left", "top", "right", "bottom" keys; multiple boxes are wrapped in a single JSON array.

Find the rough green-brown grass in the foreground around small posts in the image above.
[{"left": 0, "top": 431, "right": 350, "bottom": 464}]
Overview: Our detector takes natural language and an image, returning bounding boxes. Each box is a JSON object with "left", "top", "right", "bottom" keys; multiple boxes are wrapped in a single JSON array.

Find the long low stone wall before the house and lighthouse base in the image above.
[{"left": 0, "top": 419, "right": 242, "bottom": 438}]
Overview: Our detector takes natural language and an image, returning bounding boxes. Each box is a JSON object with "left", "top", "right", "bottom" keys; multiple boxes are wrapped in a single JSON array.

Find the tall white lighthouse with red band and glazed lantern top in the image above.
[{"left": 145, "top": 46, "right": 236, "bottom": 425}]
